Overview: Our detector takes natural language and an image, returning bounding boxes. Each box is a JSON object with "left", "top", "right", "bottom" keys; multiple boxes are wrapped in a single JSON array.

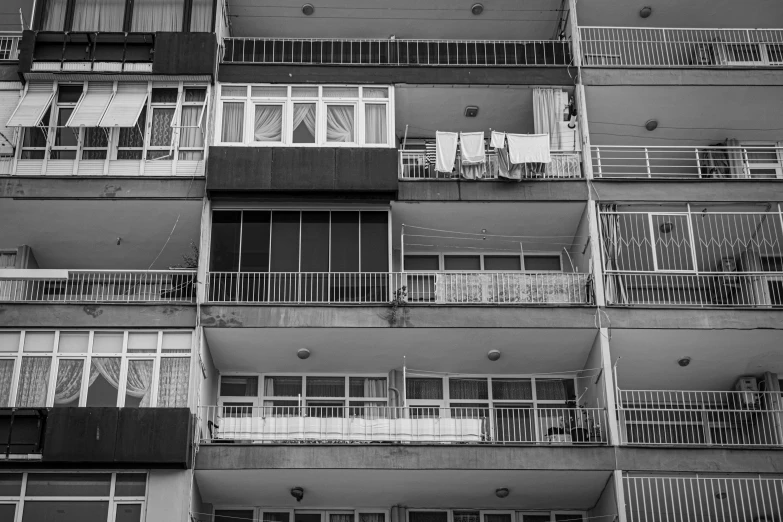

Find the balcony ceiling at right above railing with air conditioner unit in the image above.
[{"left": 611, "top": 328, "right": 783, "bottom": 391}]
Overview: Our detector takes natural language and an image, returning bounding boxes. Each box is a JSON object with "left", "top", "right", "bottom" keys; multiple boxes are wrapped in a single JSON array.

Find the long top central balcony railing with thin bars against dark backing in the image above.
[{"left": 223, "top": 38, "right": 571, "bottom": 67}]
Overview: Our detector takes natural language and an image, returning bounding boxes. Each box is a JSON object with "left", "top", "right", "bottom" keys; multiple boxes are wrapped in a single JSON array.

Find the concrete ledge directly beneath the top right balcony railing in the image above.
[{"left": 580, "top": 67, "right": 783, "bottom": 86}]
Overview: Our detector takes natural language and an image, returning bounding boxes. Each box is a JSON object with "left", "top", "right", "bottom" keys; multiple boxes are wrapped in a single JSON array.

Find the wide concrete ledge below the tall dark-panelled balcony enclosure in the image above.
[{"left": 201, "top": 304, "right": 596, "bottom": 328}]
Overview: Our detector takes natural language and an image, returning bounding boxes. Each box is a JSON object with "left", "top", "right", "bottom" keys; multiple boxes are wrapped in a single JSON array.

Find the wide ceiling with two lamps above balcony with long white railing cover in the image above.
[{"left": 205, "top": 324, "right": 595, "bottom": 374}]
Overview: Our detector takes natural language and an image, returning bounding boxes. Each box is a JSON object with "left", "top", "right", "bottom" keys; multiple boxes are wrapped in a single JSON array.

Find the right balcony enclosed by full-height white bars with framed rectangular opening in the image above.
[{"left": 600, "top": 205, "right": 783, "bottom": 308}]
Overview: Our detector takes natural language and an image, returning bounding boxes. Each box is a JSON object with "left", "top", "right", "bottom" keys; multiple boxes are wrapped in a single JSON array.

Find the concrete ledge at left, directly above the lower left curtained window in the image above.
[{"left": 0, "top": 303, "right": 196, "bottom": 328}]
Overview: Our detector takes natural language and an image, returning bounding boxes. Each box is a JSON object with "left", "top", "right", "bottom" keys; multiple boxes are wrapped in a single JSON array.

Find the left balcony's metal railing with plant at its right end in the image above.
[{"left": 0, "top": 270, "right": 196, "bottom": 303}]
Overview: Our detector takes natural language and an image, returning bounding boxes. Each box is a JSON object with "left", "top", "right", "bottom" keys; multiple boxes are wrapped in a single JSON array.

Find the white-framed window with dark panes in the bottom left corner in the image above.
[{"left": 0, "top": 472, "right": 147, "bottom": 522}]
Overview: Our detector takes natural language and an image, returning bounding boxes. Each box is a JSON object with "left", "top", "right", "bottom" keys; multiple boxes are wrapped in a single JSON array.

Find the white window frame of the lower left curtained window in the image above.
[{"left": 0, "top": 329, "right": 194, "bottom": 408}]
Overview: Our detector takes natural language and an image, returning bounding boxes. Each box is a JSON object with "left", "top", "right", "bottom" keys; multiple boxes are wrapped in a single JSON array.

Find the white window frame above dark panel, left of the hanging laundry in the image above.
[{"left": 215, "top": 83, "right": 395, "bottom": 148}]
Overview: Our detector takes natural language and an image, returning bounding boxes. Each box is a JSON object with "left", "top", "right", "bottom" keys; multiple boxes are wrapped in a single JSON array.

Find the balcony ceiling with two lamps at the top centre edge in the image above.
[{"left": 226, "top": 0, "right": 561, "bottom": 40}]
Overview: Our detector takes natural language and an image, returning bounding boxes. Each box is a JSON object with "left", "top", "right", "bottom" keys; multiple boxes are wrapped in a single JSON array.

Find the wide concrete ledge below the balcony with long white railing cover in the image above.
[{"left": 196, "top": 444, "right": 614, "bottom": 471}]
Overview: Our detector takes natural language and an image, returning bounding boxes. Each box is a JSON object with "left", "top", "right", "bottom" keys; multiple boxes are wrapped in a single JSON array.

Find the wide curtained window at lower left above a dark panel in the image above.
[{"left": 0, "top": 331, "right": 192, "bottom": 408}]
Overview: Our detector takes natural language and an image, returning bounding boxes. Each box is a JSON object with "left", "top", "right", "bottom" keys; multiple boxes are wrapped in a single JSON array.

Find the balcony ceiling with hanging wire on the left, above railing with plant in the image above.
[{"left": 0, "top": 199, "right": 201, "bottom": 270}]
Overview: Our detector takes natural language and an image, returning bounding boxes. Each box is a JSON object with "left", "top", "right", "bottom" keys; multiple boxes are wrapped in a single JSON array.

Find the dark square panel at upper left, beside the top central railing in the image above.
[{"left": 152, "top": 33, "right": 217, "bottom": 76}]
